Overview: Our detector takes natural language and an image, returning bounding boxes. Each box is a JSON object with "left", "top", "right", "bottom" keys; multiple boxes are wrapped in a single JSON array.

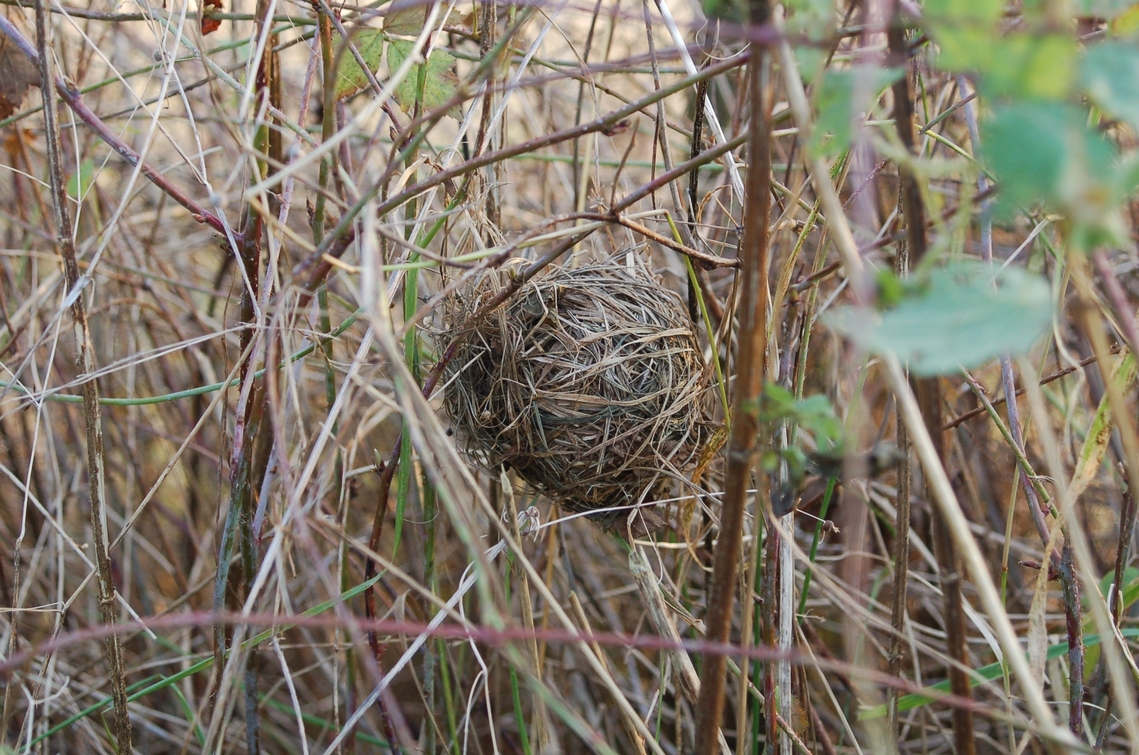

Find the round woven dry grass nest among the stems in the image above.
[{"left": 443, "top": 261, "right": 710, "bottom": 524}]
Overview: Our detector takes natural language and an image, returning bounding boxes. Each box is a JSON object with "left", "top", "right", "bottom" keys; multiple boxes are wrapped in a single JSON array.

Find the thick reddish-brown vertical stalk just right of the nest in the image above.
[{"left": 696, "top": 0, "right": 771, "bottom": 755}]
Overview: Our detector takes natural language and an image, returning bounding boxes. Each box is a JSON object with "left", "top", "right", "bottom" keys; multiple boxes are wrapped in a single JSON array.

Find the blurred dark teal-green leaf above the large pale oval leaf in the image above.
[{"left": 982, "top": 102, "right": 1126, "bottom": 236}]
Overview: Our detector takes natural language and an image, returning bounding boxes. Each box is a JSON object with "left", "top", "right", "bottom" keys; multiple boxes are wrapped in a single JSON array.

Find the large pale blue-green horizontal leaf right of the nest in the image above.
[{"left": 826, "top": 262, "right": 1052, "bottom": 375}]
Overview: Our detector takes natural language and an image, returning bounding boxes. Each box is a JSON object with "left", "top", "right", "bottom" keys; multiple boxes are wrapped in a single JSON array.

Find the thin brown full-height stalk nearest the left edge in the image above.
[{"left": 35, "top": 0, "right": 132, "bottom": 753}]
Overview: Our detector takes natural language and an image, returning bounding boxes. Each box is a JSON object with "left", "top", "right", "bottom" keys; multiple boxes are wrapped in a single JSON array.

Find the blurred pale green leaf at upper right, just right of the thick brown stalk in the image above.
[{"left": 808, "top": 66, "right": 902, "bottom": 156}]
